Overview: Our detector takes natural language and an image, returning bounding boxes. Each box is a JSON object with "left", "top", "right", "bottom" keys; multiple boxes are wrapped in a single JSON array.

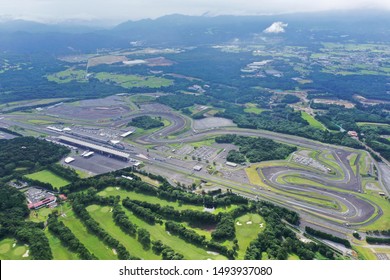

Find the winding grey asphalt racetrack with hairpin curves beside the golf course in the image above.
[{"left": 3, "top": 106, "right": 390, "bottom": 242}]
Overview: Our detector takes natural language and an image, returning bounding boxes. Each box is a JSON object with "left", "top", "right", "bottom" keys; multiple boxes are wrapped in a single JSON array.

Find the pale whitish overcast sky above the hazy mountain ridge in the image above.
[{"left": 0, "top": 0, "right": 390, "bottom": 24}]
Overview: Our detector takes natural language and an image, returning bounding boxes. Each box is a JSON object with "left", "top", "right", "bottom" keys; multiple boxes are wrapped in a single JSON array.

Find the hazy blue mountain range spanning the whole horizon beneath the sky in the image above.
[{"left": 0, "top": 11, "right": 390, "bottom": 53}]
